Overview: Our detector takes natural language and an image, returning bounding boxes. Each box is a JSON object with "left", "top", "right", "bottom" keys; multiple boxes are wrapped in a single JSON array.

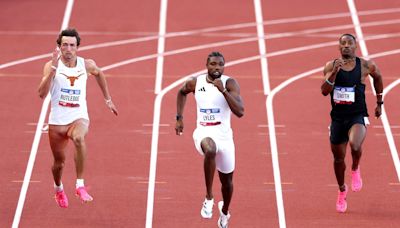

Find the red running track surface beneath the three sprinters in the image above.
[{"left": 0, "top": 0, "right": 400, "bottom": 227}]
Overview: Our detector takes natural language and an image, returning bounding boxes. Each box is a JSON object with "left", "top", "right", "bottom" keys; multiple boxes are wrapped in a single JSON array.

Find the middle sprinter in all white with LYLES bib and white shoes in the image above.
[{"left": 175, "top": 52, "right": 244, "bottom": 227}]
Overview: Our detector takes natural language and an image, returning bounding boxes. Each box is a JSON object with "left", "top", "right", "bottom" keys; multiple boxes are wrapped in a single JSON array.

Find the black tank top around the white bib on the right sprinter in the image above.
[{"left": 331, "top": 57, "right": 368, "bottom": 118}]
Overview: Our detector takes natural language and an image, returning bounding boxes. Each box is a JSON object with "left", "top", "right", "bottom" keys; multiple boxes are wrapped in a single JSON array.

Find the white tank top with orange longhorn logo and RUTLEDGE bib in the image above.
[{"left": 49, "top": 57, "right": 89, "bottom": 125}]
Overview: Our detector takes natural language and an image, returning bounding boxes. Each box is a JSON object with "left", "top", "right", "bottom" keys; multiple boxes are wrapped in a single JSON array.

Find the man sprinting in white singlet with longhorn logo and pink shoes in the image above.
[{"left": 38, "top": 29, "right": 118, "bottom": 208}]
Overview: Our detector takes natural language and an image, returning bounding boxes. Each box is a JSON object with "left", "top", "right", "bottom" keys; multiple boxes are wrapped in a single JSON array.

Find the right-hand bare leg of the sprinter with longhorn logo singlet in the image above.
[{"left": 68, "top": 119, "right": 89, "bottom": 179}]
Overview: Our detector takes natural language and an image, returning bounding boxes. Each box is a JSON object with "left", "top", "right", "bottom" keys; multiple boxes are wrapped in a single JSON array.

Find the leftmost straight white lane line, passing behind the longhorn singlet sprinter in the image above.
[{"left": 12, "top": 0, "right": 74, "bottom": 228}]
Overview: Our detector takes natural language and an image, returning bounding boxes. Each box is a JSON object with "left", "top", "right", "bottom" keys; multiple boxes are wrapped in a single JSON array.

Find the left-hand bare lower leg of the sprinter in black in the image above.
[{"left": 331, "top": 142, "right": 347, "bottom": 191}]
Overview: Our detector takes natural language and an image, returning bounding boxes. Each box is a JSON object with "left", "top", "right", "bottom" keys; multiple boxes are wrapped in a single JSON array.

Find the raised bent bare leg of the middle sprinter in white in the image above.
[{"left": 201, "top": 137, "right": 217, "bottom": 200}]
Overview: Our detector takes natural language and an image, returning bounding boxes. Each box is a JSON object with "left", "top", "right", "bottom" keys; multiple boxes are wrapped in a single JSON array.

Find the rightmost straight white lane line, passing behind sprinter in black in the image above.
[{"left": 347, "top": 0, "right": 400, "bottom": 182}]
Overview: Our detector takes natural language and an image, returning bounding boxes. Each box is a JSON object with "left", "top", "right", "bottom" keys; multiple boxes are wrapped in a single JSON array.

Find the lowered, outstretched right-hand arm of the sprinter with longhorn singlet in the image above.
[{"left": 85, "top": 59, "right": 118, "bottom": 115}]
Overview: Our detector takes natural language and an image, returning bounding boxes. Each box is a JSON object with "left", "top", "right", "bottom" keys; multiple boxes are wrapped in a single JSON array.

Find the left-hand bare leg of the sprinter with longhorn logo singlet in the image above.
[{"left": 49, "top": 125, "right": 68, "bottom": 186}]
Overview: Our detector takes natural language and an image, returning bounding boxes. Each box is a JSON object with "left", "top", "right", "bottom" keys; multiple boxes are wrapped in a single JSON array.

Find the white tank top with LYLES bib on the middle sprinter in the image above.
[{"left": 194, "top": 74, "right": 232, "bottom": 138}]
